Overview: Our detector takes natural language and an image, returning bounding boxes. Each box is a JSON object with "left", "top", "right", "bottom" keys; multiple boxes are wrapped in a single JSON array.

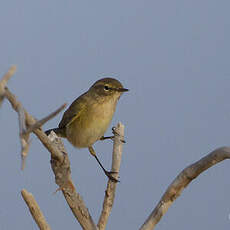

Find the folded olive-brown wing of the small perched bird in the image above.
[{"left": 58, "top": 91, "right": 87, "bottom": 128}]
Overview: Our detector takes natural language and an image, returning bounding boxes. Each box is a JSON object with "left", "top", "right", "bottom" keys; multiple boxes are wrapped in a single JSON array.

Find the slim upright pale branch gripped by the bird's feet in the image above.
[{"left": 97, "top": 122, "right": 124, "bottom": 230}]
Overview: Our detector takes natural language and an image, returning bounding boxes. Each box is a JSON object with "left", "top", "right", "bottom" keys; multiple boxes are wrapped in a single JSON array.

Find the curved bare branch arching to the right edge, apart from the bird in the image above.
[{"left": 140, "top": 147, "right": 230, "bottom": 230}]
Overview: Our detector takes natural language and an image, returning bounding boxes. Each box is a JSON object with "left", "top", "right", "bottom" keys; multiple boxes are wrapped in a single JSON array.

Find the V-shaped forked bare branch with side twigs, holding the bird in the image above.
[{"left": 4, "top": 68, "right": 124, "bottom": 230}]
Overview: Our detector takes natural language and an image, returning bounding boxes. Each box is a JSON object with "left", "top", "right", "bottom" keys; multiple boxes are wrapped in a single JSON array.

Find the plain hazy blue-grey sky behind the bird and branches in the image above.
[{"left": 0, "top": 0, "right": 230, "bottom": 230}]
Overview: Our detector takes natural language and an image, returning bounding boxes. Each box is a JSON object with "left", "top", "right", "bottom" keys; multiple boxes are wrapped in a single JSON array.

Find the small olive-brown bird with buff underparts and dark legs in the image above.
[{"left": 45, "top": 78, "right": 128, "bottom": 182}]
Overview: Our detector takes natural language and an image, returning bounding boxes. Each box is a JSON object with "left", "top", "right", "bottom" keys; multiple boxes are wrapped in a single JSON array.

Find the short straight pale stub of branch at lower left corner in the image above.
[{"left": 21, "top": 189, "right": 50, "bottom": 230}]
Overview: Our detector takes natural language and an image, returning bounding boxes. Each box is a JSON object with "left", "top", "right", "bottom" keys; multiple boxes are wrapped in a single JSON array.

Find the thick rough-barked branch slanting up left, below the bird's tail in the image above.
[{"left": 5, "top": 88, "right": 97, "bottom": 230}]
